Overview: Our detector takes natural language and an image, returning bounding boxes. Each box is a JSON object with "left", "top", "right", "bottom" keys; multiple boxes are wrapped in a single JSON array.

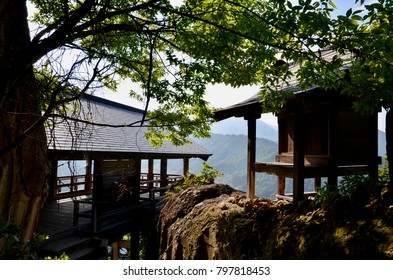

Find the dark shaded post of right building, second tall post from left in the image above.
[{"left": 293, "top": 115, "right": 304, "bottom": 204}]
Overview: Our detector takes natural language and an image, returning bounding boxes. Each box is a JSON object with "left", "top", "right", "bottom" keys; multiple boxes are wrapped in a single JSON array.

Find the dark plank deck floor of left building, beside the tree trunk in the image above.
[{"left": 37, "top": 199, "right": 90, "bottom": 236}]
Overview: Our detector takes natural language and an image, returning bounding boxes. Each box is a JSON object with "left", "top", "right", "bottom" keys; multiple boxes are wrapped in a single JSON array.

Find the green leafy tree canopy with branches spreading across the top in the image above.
[{"left": 32, "top": 0, "right": 393, "bottom": 144}]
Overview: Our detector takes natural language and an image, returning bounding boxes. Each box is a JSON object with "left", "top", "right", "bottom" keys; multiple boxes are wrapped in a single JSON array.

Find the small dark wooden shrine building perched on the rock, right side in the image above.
[{"left": 215, "top": 53, "right": 381, "bottom": 203}]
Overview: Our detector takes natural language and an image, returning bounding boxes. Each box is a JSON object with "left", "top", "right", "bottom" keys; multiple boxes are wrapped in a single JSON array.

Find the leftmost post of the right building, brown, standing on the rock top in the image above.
[{"left": 247, "top": 118, "right": 257, "bottom": 199}]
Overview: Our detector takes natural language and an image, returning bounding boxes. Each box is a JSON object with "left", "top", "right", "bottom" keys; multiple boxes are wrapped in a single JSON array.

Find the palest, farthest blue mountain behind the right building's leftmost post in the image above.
[{"left": 211, "top": 118, "right": 278, "bottom": 142}]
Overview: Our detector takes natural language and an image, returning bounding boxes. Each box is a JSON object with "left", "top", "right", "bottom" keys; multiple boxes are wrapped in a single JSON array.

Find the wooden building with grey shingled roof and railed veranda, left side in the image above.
[{"left": 38, "top": 96, "right": 211, "bottom": 259}]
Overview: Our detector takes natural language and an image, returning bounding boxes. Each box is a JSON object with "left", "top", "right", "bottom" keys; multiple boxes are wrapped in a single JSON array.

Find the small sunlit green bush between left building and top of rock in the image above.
[{"left": 166, "top": 162, "right": 223, "bottom": 195}]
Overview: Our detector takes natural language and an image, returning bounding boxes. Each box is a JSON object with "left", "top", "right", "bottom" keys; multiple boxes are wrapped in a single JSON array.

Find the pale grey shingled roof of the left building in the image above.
[{"left": 47, "top": 95, "right": 212, "bottom": 159}]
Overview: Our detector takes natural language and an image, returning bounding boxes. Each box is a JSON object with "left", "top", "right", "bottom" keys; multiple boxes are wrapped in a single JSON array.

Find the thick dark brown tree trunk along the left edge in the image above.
[{"left": 0, "top": 0, "right": 49, "bottom": 258}]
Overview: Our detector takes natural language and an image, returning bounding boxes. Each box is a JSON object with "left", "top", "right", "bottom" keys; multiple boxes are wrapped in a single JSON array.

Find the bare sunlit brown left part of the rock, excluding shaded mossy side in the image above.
[{"left": 159, "top": 184, "right": 288, "bottom": 260}]
